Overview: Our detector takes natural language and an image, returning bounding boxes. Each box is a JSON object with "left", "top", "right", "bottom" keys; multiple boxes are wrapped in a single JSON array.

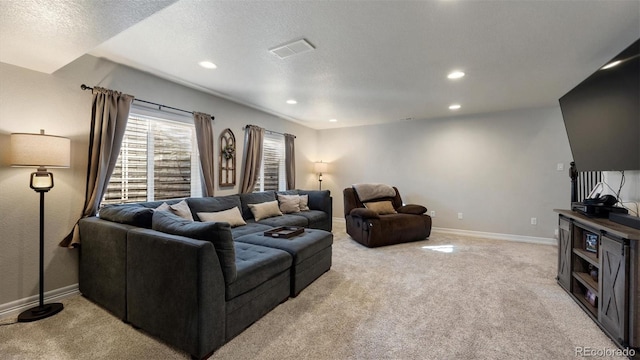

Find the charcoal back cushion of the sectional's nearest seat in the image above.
[{"left": 152, "top": 211, "right": 237, "bottom": 284}]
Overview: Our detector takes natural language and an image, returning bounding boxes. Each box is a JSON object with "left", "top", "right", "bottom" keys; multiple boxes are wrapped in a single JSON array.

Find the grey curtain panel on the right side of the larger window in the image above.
[{"left": 193, "top": 112, "right": 215, "bottom": 196}]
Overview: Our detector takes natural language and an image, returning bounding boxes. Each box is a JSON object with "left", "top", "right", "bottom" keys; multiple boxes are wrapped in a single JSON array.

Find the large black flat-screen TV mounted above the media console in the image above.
[{"left": 559, "top": 39, "right": 640, "bottom": 171}]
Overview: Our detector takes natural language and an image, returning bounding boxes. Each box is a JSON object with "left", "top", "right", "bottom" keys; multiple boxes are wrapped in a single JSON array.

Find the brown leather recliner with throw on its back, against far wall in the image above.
[{"left": 343, "top": 187, "right": 431, "bottom": 247}]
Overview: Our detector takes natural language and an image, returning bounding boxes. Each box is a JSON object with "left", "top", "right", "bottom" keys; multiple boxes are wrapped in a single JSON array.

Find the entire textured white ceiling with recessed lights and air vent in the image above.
[{"left": 0, "top": 0, "right": 640, "bottom": 129}]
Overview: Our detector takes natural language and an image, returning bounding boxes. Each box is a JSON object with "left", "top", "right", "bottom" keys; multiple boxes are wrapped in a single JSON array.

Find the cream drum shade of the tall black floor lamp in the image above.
[{"left": 11, "top": 130, "right": 71, "bottom": 168}]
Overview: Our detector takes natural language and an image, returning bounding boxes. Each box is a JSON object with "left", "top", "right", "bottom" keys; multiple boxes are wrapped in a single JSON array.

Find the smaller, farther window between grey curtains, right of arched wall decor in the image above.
[{"left": 253, "top": 134, "right": 287, "bottom": 191}]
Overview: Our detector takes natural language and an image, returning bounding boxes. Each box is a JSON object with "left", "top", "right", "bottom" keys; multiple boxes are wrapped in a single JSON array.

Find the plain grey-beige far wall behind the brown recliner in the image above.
[{"left": 318, "top": 107, "right": 571, "bottom": 238}]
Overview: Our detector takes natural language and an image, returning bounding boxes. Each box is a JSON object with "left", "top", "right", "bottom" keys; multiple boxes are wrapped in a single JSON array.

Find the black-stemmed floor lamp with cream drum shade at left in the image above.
[{"left": 11, "top": 130, "right": 71, "bottom": 322}]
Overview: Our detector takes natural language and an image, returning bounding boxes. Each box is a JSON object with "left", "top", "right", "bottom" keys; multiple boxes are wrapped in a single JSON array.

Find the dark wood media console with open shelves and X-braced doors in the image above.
[{"left": 555, "top": 210, "right": 640, "bottom": 358}]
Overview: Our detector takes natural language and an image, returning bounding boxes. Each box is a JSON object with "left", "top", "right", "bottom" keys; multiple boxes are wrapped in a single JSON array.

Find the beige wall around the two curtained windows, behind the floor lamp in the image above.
[{"left": 0, "top": 56, "right": 317, "bottom": 305}]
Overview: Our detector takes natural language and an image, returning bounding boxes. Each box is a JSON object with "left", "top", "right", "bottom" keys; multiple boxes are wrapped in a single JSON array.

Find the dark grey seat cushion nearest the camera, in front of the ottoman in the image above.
[{"left": 225, "top": 242, "right": 292, "bottom": 301}]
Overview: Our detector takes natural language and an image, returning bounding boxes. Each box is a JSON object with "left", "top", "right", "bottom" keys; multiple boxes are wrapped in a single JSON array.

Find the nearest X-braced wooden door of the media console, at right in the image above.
[{"left": 598, "top": 236, "right": 629, "bottom": 344}]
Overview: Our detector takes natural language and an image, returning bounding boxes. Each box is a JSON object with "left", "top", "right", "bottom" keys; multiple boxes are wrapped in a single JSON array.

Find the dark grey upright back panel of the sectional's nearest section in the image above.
[{"left": 127, "top": 229, "right": 226, "bottom": 358}]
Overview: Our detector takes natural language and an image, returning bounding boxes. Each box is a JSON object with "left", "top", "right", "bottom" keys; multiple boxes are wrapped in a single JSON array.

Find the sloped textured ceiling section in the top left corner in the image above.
[{"left": 0, "top": 0, "right": 176, "bottom": 74}]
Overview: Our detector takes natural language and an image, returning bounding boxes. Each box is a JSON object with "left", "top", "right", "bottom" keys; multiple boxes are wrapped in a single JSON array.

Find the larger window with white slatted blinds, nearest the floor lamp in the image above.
[{"left": 102, "top": 113, "right": 202, "bottom": 204}]
